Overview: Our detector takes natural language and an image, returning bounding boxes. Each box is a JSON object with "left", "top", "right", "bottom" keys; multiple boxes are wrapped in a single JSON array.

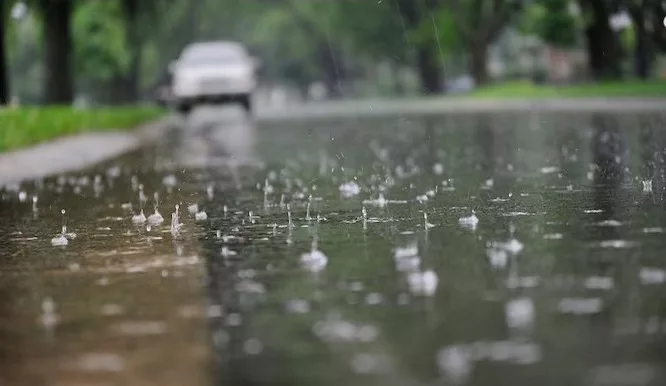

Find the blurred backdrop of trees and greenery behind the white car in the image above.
[{"left": 0, "top": 0, "right": 666, "bottom": 105}]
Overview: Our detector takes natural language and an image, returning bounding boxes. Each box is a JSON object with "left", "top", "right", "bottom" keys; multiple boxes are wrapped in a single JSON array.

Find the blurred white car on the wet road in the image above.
[{"left": 169, "top": 41, "right": 258, "bottom": 113}]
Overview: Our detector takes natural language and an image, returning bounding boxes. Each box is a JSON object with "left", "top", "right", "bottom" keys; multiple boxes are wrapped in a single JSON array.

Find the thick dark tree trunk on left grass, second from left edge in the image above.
[{"left": 40, "top": 0, "right": 74, "bottom": 105}]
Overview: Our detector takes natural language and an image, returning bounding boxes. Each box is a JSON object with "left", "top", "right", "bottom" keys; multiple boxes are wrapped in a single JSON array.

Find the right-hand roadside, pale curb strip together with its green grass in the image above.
[{"left": 257, "top": 81, "right": 666, "bottom": 121}]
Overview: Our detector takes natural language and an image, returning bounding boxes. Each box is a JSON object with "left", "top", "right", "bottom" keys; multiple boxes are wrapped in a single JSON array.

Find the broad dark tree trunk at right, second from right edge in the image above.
[{"left": 580, "top": 0, "right": 622, "bottom": 80}]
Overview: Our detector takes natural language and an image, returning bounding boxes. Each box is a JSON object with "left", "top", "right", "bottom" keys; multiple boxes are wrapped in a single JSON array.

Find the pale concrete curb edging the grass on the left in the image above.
[{"left": 0, "top": 115, "right": 174, "bottom": 187}]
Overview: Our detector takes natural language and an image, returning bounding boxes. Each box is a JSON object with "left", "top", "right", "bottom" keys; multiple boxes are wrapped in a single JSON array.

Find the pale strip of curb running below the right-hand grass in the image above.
[{"left": 256, "top": 98, "right": 666, "bottom": 121}]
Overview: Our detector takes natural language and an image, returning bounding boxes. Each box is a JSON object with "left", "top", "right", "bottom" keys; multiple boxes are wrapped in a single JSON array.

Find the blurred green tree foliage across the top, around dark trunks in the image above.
[{"left": 0, "top": 0, "right": 666, "bottom": 101}]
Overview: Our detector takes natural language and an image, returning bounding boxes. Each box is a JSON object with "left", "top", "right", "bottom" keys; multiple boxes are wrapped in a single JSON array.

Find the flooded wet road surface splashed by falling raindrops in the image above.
[{"left": 0, "top": 109, "right": 666, "bottom": 386}]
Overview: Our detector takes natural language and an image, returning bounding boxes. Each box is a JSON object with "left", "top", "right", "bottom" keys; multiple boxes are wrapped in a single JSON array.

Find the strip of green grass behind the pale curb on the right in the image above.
[{"left": 466, "top": 80, "right": 666, "bottom": 98}]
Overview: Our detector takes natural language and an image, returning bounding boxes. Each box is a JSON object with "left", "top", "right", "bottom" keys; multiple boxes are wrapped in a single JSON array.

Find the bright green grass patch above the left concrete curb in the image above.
[{"left": 0, "top": 107, "right": 166, "bottom": 152}]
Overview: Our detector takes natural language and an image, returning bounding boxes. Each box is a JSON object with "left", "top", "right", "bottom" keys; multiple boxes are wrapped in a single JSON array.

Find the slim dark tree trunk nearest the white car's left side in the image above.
[{"left": 122, "top": 0, "right": 142, "bottom": 102}]
